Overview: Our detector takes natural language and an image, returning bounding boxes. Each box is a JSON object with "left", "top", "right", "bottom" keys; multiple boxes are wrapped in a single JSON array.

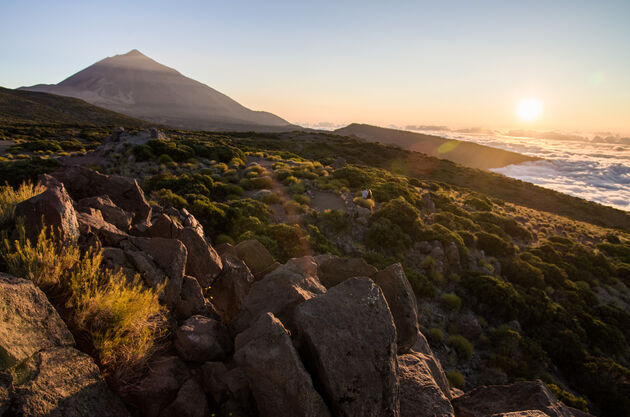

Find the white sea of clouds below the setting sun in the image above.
[{"left": 407, "top": 126, "right": 630, "bottom": 211}]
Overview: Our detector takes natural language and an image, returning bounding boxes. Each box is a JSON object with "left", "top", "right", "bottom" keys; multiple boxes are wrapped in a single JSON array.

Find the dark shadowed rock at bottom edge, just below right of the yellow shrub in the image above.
[{"left": 130, "top": 356, "right": 190, "bottom": 417}]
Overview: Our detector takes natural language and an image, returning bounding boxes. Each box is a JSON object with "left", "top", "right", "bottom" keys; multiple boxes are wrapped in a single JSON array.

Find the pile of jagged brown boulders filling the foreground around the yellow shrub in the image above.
[{"left": 0, "top": 167, "right": 587, "bottom": 417}]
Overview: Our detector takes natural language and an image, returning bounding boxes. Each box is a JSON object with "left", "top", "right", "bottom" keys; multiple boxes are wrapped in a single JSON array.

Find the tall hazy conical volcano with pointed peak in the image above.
[{"left": 22, "top": 49, "right": 293, "bottom": 130}]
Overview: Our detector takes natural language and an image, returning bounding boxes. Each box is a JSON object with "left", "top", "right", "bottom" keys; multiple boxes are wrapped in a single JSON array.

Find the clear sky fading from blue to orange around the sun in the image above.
[{"left": 0, "top": 0, "right": 630, "bottom": 135}]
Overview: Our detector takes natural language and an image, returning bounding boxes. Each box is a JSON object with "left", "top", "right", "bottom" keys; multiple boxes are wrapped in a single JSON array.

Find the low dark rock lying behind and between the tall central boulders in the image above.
[{"left": 314, "top": 254, "right": 378, "bottom": 288}]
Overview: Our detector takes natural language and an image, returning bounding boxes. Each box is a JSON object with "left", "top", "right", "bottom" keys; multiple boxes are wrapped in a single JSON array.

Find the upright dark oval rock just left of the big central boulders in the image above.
[{"left": 208, "top": 255, "right": 254, "bottom": 323}]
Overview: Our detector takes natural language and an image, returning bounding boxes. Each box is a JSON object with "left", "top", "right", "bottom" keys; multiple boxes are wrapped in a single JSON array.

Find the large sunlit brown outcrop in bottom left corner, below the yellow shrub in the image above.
[{"left": 0, "top": 274, "right": 129, "bottom": 417}]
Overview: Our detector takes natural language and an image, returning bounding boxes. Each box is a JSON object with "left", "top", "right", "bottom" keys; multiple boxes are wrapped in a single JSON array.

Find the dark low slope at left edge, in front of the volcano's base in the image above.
[{"left": 0, "top": 87, "right": 149, "bottom": 127}]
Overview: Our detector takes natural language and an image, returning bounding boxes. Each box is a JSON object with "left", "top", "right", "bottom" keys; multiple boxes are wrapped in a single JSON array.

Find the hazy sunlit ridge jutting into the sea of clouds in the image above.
[{"left": 335, "top": 123, "right": 538, "bottom": 170}]
